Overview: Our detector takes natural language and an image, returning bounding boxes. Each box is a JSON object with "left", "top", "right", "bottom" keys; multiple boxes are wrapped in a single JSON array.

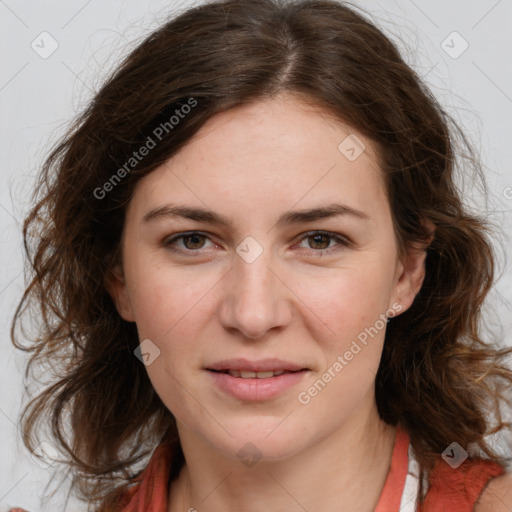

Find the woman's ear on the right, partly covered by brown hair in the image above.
[{"left": 394, "top": 221, "right": 435, "bottom": 313}]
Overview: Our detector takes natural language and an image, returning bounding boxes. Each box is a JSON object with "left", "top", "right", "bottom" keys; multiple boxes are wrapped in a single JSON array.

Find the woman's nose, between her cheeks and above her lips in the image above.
[{"left": 220, "top": 245, "right": 293, "bottom": 339}]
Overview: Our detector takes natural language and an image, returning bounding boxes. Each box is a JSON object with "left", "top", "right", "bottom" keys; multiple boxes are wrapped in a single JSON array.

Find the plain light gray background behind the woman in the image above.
[{"left": 0, "top": 0, "right": 512, "bottom": 512}]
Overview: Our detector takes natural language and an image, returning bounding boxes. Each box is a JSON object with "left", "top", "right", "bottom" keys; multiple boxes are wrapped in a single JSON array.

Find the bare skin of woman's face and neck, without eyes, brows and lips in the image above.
[{"left": 109, "top": 94, "right": 432, "bottom": 512}]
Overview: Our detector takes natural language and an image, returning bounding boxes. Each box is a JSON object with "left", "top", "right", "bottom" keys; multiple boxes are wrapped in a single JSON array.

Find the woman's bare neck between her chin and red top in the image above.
[{"left": 168, "top": 400, "right": 396, "bottom": 512}]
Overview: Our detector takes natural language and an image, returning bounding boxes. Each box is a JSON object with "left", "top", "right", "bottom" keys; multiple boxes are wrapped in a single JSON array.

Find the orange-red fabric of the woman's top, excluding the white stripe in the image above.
[{"left": 6, "top": 426, "right": 504, "bottom": 512}]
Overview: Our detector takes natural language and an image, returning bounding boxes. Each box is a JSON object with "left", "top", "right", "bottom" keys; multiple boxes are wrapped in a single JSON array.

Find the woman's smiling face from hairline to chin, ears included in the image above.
[{"left": 109, "top": 95, "right": 424, "bottom": 459}]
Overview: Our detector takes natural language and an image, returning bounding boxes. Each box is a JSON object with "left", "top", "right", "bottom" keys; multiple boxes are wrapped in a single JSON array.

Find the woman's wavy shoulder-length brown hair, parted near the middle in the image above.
[{"left": 12, "top": 0, "right": 512, "bottom": 510}]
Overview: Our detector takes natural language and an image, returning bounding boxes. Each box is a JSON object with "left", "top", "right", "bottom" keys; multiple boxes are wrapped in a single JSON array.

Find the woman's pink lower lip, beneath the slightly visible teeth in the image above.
[{"left": 208, "top": 370, "right": 307, "bottom": 401}]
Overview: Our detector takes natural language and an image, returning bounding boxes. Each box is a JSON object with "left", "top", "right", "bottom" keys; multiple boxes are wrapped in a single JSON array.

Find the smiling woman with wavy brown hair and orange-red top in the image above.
[{"left": 9, "top": 0, "right": 512, "bottom": 512}]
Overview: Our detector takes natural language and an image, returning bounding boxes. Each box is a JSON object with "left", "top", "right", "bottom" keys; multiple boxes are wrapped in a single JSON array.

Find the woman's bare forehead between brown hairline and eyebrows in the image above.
[{"left": 129, "top": 95, "right": 388, "bottom": 228}]
